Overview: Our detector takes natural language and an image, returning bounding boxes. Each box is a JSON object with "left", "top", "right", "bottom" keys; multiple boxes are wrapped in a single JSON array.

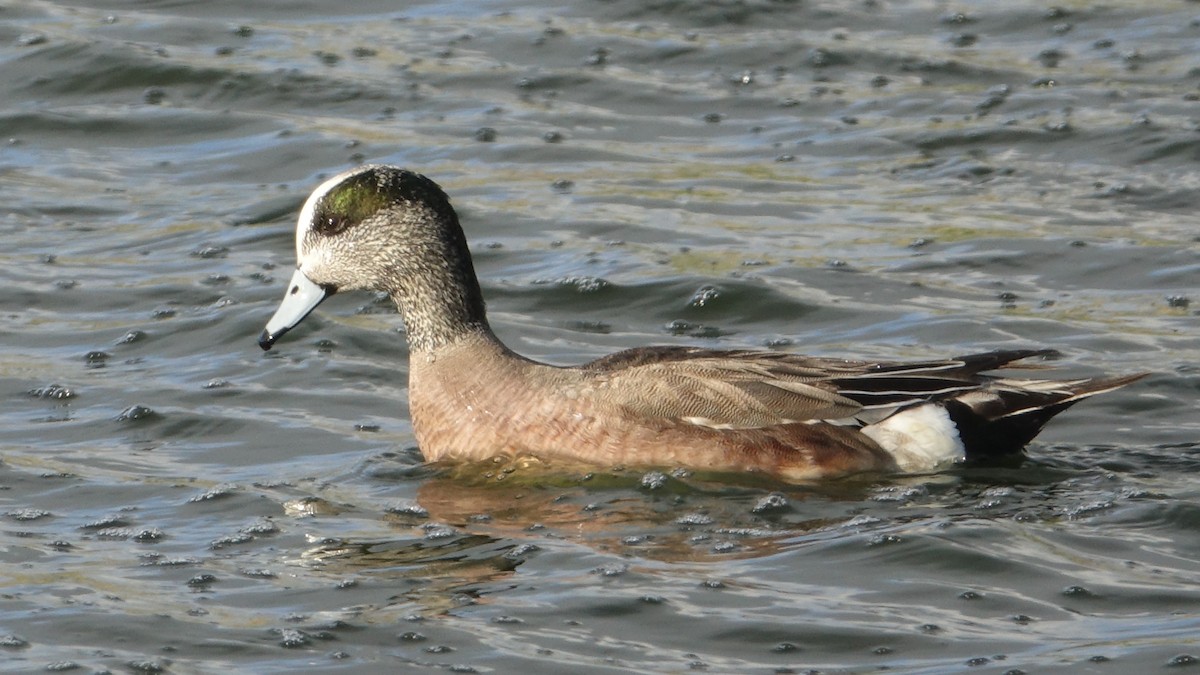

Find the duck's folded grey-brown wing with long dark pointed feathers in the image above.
[{"left": 581, "top": 347, "right": 1052, "bottom": 429}]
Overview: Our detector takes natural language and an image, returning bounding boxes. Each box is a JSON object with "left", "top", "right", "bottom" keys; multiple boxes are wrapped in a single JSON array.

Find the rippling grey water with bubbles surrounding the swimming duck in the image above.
[{"left": 0, "top": 0, "right": 1200, "bottom": 674}]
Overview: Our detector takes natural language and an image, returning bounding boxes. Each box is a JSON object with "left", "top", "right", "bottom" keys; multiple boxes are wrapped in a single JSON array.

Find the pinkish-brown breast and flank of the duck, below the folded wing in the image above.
[{"left": 409, "top": 340, "right": 898, "bottom": 479}]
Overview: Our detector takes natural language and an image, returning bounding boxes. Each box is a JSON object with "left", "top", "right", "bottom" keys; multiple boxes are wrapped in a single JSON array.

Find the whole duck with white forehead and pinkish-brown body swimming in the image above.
[{"left": 258, "top": 165, "right": 1146, "bottom": 482}]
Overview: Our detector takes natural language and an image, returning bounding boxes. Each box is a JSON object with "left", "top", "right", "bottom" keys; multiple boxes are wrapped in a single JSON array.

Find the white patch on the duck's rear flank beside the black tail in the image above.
[{"left": 863, "top": 404, "right": 966, "bottom": 472}]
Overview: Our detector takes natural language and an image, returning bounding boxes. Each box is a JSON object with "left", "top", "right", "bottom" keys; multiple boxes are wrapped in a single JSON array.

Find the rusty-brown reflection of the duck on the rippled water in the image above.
[{"left": 297, "top": 456, "right": 892, "bottom": 583}]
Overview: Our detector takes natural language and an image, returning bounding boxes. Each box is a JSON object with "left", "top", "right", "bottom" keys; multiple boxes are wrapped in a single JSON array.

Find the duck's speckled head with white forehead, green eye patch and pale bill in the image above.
[{"left": 258, "top": 165, "right": 485, "bottom": 350}]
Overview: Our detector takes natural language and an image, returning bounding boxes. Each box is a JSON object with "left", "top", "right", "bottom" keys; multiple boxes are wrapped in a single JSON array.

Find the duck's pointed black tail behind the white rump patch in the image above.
[{"left": 942, "top": 372, "right": 1147, "bottom": 461}]
